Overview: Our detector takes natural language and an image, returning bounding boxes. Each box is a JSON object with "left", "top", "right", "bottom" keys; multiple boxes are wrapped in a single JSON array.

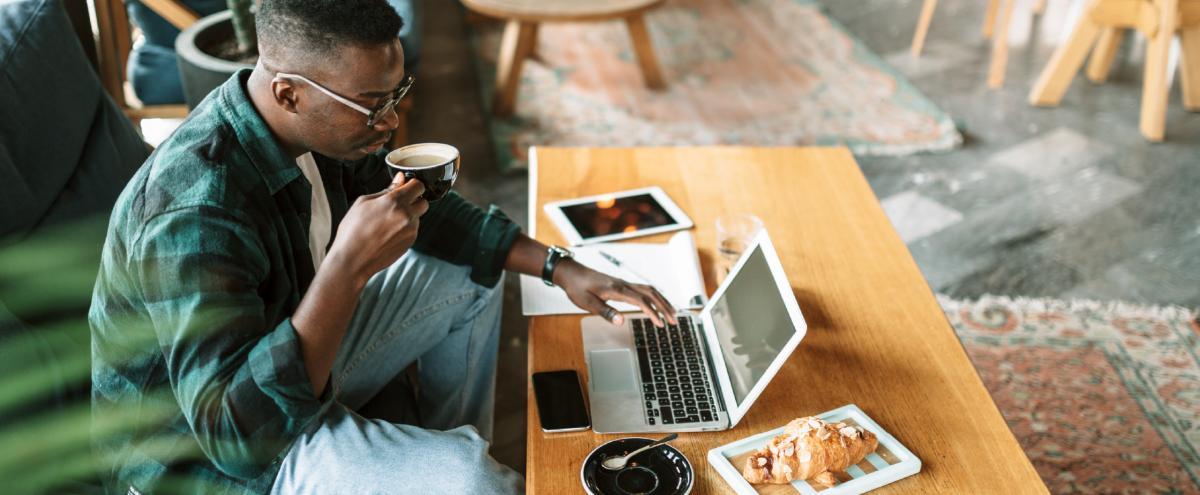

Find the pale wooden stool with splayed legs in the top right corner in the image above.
[{"left": 1030, "top": 0, "right": 1200, "bottom": 142}]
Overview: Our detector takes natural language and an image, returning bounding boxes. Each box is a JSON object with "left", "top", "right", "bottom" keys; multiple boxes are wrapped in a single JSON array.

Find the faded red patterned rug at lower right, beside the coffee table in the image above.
[{"left": 941, "top": 297, "right": 1200, "bottom": 494}]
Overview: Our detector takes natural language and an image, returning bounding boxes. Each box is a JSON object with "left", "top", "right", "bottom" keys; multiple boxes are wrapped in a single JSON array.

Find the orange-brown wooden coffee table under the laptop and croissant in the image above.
[{"left": 526, "top": 148, "right": 1046, "bottom": 494}]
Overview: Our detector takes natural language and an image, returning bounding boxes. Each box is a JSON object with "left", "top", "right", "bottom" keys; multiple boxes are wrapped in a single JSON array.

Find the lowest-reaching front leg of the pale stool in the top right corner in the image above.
[{"left": 1139, "top": 0, "right": 1180, "bottom": 142}]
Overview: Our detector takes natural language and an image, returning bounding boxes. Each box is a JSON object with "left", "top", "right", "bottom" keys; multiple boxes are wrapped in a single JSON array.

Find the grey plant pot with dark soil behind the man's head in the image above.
[{"left": 175, "top": 0, "right": 258, "bottom": 108}]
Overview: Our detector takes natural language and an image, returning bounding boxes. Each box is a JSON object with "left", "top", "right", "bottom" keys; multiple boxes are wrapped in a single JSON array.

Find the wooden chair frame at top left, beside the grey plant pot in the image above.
[{"left": 91, "top": 0, "right": 199, "bottom": 124}]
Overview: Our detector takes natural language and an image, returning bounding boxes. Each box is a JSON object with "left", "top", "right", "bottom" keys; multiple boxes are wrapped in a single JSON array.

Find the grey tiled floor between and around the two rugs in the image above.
[{"left": 409, "top": 0, "right": 1200, "bottom": 471}]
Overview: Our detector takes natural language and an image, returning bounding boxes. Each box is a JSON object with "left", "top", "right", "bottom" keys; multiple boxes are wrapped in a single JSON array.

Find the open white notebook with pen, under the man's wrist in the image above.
[{"left": 521, "top": 231, "right": 708, "bottom": 316}]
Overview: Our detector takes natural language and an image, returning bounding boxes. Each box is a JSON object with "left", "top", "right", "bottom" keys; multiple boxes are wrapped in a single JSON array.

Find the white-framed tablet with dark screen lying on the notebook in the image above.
[{"left": 545, "top": 187, "right": 692, "bottom": 246}]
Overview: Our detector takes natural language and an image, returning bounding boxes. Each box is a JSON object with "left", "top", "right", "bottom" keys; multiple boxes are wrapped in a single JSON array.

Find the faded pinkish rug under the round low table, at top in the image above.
[{"left": 465, "top": 0, "right": 962, "bottom": 168}]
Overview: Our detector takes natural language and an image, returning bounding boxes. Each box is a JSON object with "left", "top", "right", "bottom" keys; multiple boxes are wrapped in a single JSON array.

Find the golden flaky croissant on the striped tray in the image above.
[{"left": 742, "top": 417, "right": 880, "bottom": 487}]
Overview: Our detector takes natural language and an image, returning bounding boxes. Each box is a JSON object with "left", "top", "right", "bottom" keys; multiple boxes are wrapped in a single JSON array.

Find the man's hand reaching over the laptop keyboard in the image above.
[{"left": 554, "top": 258, "right": 679, "bottom": 327}]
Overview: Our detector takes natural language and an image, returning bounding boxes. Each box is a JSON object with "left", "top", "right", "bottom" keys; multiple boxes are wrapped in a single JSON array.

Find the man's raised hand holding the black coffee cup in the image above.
[{"left": 329, "top": 174, "right": 430, "bottom": 282}]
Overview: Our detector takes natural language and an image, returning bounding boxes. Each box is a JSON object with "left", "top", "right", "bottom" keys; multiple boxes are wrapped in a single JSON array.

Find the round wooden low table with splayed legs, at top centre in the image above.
[{"left": 462, "top": 0, "right": 666, "bottom": 117}]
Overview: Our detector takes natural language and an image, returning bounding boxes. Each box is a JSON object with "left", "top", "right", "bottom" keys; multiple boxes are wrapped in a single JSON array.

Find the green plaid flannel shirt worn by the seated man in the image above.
[{"left": 89, "top": 70, "right": 518, "bottom": 493}]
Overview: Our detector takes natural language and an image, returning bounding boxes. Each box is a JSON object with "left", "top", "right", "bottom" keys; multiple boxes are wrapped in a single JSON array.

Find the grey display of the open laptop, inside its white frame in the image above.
[{"left": 710, "top": 244, "right": 796, "bottom": 405}]
